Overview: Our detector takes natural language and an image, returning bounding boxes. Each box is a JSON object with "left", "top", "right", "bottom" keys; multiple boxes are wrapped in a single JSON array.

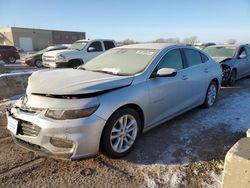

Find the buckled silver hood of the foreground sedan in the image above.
[{"left": 27, "top": 69, "right": 134, "bottom": 95}]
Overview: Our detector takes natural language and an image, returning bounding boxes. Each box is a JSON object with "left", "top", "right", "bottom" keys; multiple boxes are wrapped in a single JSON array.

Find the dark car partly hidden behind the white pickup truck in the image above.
[{"left": 24, "top": 44, "right": 70, "bottom": 67}]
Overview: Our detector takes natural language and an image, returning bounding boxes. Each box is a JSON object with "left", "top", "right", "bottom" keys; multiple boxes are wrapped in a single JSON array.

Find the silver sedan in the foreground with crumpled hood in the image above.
[{"left": 8, "top": 43, "right": 222, "bottom": 159}]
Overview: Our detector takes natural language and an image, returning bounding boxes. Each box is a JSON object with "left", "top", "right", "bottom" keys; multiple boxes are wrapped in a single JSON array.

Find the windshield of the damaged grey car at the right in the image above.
[{"left": 204, "top": 46, "right": 236, "bottom": 58}]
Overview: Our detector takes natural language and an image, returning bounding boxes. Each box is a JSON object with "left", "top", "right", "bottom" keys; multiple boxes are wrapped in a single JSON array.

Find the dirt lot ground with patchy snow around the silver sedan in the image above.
[{"left": 0, "top": 78, "right": 250, "bottom": 188}]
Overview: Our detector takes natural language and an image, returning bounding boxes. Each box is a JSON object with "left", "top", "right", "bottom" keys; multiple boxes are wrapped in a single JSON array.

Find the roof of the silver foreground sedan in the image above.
[{"left": 118, "top": 43, "right": 180, "bottom": 50}]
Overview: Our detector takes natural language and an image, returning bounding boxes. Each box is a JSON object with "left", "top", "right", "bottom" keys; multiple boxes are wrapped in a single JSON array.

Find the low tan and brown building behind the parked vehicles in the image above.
[{"left": 0, "top": 27, "right": 86, "bottom": 51}]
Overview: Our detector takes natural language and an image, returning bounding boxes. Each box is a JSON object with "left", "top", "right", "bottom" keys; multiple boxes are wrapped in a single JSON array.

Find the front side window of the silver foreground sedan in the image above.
[{"left": 157, "top": 49, "right": 183, "bottom": 70}]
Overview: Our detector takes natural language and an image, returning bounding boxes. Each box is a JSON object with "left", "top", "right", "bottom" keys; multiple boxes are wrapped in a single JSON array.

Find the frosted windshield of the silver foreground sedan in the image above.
[{"left": 83, "top": 48, "right": 158, "bottom": 76}]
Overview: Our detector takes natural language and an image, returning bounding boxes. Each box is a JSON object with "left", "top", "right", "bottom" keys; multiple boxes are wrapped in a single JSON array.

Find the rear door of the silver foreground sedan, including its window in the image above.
[{"left": 182, "top": 48, "right": 209, "bottom": 106}]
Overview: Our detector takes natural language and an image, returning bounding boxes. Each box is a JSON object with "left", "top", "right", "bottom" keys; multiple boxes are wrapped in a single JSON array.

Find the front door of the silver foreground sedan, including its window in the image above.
[{"left": 147, "top": 49, "right": 190, "bottom": 125}]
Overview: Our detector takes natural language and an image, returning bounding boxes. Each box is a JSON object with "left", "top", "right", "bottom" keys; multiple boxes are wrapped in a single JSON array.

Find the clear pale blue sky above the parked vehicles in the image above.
[{"left": 0, "top": 0, "right": 250, "bottom": 43}]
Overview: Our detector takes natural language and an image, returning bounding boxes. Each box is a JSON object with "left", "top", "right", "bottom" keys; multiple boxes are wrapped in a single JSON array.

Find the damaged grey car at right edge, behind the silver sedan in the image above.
[{"left": 204, "top": 45, "right": 250, "bottom": 85}]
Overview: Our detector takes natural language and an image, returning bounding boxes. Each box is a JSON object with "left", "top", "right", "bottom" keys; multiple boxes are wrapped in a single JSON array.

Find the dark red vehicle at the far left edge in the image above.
[{"left": 0, "top": 45, "right": 20, "bottom": 63}]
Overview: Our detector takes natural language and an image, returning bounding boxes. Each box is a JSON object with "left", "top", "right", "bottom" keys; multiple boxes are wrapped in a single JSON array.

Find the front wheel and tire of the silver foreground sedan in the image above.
[{"left": 100, "top": 108, "right": 141, "bottom": 158}]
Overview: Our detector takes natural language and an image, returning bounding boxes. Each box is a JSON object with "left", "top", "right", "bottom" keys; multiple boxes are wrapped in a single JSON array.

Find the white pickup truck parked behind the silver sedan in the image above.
[{"left": 42, "top": 39, "right": 116, "bottom": 68}]
